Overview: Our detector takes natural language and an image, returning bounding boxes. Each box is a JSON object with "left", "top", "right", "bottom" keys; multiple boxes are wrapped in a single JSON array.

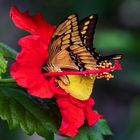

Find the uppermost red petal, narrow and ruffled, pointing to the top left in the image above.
[{"left": 10, "top": 6, "right": 55, "bottom": 46}]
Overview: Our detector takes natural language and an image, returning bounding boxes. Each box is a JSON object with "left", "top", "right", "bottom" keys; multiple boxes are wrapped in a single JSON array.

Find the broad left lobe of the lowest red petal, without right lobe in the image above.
[{"left": 56, "top": 96, "right": 85, "bottom": 137}]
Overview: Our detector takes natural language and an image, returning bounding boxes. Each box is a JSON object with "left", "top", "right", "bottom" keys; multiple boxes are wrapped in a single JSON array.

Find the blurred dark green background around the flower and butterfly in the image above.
[{"left": 0, "top": 0, "right": 140, "bottom": 140}]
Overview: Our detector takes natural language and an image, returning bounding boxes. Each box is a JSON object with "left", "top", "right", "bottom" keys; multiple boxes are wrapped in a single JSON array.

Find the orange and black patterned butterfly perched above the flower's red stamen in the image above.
[{"left": 45, "top": 14, "right": 121, "bottom": 84}]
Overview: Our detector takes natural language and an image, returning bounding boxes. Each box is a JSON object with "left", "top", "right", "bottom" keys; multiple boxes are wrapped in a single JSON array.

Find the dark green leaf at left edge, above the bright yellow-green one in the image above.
[{"left": 0, "top": 42, "right": 17, "bottom": 59}]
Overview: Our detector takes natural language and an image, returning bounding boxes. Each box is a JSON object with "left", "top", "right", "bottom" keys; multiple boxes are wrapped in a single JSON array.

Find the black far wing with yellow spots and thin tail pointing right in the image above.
[{"left": 79, "top": 14, "right": 122, "bottom": 65}]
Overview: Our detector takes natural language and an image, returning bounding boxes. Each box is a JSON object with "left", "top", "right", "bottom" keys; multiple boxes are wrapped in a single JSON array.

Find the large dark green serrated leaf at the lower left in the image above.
[{"left": 0, "top": 84, "right": 57, "bottom": 140}]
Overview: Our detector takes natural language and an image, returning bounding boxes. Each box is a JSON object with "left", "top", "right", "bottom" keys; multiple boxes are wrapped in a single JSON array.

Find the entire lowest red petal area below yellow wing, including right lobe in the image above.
[{"left": 55, "top": 94, "right": 103, "bottom": 137}]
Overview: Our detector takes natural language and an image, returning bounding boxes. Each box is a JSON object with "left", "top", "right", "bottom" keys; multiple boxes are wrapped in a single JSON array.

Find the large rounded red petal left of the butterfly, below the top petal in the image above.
[{"left": 10, "top": 36, "right": 54, "bottom": 98}]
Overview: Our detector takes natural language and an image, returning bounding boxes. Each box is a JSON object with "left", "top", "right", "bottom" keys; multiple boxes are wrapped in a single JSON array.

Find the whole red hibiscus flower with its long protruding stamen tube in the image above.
[{"left": 10, "top": 7, "right": 120, "bottom": 137}]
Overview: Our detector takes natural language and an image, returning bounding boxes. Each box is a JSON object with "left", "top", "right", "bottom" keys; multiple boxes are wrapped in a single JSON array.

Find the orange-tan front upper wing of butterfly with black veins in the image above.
[{"left": 47, "top": 14, "right": 83, "bottom": 71}]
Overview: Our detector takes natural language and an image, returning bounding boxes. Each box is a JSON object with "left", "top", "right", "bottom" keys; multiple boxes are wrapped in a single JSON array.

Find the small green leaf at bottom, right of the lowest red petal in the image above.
[{"left": 68, "top": 119, "right": 112, "bottom": 140}]
